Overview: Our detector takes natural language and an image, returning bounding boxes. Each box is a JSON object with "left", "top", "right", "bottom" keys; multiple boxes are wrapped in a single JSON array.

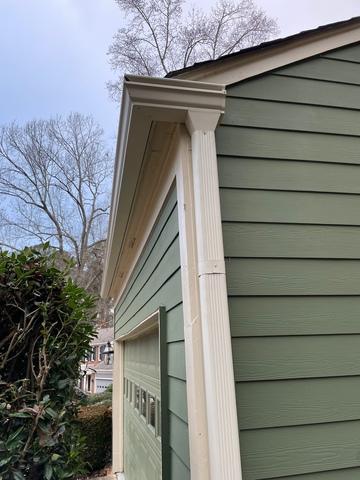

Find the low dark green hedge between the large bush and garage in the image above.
[{"left": 77, "top": 404, "right": 112, "bottom": 472}]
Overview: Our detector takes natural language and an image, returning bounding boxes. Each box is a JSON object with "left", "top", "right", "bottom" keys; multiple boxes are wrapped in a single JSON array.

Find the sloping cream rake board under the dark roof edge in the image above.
[{"left": 173, "top": 22, "right": 360, "bottom": 86}]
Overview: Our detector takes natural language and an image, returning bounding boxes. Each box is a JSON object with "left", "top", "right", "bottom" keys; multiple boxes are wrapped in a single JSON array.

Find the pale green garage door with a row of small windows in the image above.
[{"left": 124, "top": 330, "right": 161, "bottom": 480}]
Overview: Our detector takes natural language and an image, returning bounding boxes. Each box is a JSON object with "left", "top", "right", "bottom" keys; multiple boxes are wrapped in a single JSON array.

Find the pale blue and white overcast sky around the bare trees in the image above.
[{"left": 0, "top": 0, "right": 360, "bottom": 145}]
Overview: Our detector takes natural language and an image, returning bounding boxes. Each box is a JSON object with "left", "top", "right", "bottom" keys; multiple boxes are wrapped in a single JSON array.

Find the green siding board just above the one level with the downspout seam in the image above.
[{"left": 222, "top": 222, "right": 360, "bottom": 259}]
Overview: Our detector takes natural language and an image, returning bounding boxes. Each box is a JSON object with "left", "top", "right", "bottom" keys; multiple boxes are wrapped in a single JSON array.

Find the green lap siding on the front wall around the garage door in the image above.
[{"left": 115, "top": 189, "right": 190, "bottom": 480}]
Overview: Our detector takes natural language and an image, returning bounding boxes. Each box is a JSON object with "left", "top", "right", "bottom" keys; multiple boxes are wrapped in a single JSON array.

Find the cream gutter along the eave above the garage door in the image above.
[{"left": 101, "top": 75, "right": 225, "bottom": 297}]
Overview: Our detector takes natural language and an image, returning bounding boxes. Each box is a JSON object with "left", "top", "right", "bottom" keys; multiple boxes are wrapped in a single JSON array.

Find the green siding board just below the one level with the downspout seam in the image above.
[{"left": 229, "top": 296, "right": 360, "bottom": 337}]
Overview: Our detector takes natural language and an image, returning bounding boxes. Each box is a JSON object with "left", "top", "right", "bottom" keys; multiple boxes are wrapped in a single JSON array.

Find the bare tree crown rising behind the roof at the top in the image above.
[{"left": 108, "top": 0, "right": 278, "bottom": 99}]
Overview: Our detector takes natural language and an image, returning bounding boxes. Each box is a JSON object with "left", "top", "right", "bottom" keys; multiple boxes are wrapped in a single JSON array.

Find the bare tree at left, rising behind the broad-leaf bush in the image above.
[{"left": 0, "top": 113, "right": 112, "bottom": 308}]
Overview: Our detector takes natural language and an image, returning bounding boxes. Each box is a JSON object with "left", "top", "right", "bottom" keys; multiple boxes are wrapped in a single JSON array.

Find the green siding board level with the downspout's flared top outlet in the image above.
[{"left": 221, "top": 97, "right": 360, "bottom": 135}]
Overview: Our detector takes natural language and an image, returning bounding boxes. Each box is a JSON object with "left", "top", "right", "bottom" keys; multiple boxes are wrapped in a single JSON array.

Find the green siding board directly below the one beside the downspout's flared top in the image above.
[{"left": 216, "top": 124, "right": 360, "bottom": 164}]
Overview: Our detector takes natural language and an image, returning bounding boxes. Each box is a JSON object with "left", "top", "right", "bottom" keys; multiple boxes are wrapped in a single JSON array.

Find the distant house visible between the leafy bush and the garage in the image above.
[{"left": 80, "top": 328, "right": 114, "bottom": 393}]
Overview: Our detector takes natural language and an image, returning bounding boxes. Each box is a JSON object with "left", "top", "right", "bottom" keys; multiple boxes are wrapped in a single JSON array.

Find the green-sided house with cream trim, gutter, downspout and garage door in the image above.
[{"left": 103, "top": 18, "right": 360, "bottom": 480}]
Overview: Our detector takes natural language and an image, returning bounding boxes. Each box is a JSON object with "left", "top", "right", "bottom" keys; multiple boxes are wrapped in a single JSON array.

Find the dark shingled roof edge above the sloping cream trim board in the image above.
[{"left": 166, "top": 16, "right": 360, "bottom": 78}]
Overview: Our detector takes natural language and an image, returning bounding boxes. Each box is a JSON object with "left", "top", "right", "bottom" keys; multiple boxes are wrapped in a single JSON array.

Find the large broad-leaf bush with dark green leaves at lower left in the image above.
[{"left": 0, "top": 249, "right": 95, "bottom": 480}]
